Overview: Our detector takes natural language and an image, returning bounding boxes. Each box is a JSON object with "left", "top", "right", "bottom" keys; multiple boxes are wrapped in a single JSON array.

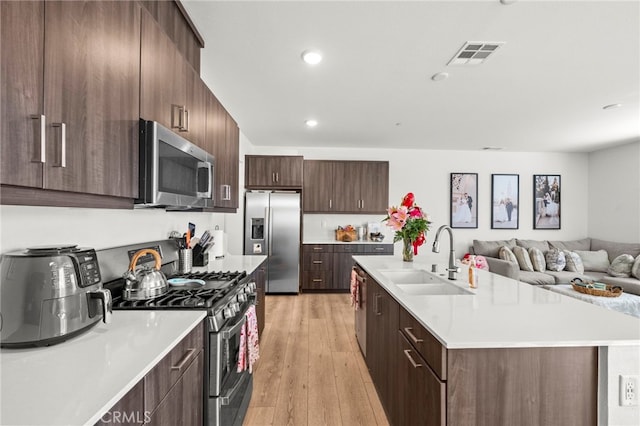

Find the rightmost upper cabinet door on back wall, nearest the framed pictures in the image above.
[{"left": 360, "top": 161, "right": 389, "bottom": 213}]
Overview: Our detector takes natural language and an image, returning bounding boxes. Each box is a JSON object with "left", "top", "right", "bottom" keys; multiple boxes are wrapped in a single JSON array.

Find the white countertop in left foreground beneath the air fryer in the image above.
[{"left": 0, "top": 311, "right": 206, "bottom": 425}]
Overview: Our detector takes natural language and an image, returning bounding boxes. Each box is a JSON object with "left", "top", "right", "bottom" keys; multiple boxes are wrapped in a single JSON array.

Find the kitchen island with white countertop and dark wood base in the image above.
[{"left": 354, "top": 256, "right": 640, "bottom": 425}]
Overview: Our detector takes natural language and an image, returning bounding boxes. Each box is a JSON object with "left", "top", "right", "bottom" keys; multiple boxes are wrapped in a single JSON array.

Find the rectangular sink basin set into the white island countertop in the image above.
[{"left": 380, "top": 269, "right": 473, "bottom": 295}]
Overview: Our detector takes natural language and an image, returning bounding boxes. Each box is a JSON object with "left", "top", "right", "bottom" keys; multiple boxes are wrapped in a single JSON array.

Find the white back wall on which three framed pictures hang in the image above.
[{"left": 254, "top": 146, "right": 589, "bottom": 257}]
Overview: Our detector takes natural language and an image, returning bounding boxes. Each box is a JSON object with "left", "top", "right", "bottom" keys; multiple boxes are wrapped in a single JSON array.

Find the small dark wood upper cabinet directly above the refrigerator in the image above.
[{"left": 244, "top": 155, "right": 303, "bottom": 189}]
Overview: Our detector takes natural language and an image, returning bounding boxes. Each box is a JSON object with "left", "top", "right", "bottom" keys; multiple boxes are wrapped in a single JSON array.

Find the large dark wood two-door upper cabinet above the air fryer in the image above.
[{"left": 0, "top": 1, "right": 141, "bottom": 205}]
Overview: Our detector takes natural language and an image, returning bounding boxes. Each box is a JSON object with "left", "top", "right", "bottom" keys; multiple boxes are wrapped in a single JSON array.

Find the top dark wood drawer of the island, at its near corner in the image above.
[{"left": 400, "top": 308, "right": 447, "bottom": 380}]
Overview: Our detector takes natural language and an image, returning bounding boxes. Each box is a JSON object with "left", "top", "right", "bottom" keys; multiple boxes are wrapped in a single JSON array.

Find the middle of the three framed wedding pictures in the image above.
[{"left": 491, "top": 174, "right": 520, "bottom": 229}]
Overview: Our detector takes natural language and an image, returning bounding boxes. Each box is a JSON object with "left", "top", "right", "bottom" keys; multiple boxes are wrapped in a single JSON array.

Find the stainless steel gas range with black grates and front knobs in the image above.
[{"left": 98, "top": 241, "right": 256, "bottom": 426}]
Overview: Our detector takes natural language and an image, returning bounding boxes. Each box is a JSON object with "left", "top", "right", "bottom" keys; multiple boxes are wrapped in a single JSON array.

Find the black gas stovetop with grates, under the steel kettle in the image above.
[{"left": 109, "top": 271, "right": 247, "bottom": 310}]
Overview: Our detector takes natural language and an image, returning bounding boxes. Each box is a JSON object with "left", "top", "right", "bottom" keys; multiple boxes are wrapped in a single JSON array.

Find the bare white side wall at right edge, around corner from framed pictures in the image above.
[{"left": 587, "top": 142, "right": 640, "bottom": 243}]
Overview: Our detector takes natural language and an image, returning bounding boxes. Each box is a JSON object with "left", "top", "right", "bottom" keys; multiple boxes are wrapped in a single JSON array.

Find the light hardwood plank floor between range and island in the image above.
[{"left": 244, "top": 293, "right": 389, "bottom": 426}]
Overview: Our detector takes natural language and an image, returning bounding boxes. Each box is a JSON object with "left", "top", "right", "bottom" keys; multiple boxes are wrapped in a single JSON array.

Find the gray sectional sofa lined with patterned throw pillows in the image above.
[{"left": 471, "top": 238, "right": 640, "bottom": 295}]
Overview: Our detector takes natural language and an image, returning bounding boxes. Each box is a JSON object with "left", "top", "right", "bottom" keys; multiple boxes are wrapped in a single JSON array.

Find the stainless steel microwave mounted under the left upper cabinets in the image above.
[{"left": 135, "top": 119, "right": 214, "bottom": 209}]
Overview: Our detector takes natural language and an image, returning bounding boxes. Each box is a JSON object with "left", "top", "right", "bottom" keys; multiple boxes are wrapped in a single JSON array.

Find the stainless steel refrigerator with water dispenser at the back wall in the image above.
[{"left": 244, "top": 191, "right": 300, "bottom": 294}]
